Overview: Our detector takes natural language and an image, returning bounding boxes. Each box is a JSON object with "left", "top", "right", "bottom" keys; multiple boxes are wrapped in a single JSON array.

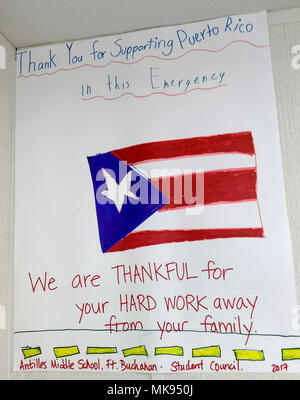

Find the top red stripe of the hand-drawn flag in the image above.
[{"left": 111, "top": 132, "right": 255, "bottom": 164}]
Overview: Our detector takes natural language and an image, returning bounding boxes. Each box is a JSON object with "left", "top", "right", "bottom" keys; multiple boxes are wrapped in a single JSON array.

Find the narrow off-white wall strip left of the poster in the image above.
[{"left": 0, "top": 34, "right": 15, "bottom": 379}]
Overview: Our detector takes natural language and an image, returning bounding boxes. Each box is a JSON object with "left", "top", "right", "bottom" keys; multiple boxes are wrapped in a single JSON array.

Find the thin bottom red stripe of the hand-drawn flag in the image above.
[{"left": 108, "top": 228, "right": 264, "bottom": 253}]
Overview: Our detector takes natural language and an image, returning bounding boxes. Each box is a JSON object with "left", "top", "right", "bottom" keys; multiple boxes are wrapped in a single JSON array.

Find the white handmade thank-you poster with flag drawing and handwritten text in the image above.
[{"left": 14, "top": 12, "right": 300, "bottom": 374}]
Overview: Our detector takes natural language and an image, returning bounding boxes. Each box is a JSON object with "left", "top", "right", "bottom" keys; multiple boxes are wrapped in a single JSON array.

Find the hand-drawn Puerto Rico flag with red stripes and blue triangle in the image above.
[{"left": 88, "top": 132, "right": 264, "bottom": 252}]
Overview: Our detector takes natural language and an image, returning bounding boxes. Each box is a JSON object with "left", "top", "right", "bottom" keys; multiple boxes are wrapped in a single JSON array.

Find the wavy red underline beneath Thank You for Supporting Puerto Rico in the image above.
[{"left": 18, "top": 40, "right": 270, "bottom": 78}]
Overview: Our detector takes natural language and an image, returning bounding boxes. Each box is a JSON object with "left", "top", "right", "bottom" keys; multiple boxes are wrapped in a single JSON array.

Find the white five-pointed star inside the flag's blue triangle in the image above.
[{"left": 101, "top": 168, "right": 138, "bottom": 213}]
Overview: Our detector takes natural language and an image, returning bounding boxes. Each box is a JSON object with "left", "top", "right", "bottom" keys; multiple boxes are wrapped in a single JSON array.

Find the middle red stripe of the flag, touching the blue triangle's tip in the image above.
[{"left": 151, "top": 168, "right": 257, "bottom": 212}]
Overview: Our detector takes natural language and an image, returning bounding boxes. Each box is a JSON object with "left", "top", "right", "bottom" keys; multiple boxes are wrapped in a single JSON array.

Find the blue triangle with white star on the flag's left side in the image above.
[{"left": 88, "top": 153, "right": 168, "bottom": 253}]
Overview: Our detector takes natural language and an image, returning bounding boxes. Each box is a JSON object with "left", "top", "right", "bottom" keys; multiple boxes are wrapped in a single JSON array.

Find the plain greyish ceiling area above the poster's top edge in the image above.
[{"left": 0, "top": 0, "right": 300, "bottom": 47}]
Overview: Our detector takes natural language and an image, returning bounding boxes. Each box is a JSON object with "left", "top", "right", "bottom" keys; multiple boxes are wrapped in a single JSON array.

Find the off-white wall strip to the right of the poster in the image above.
[{"left": 270, "top": 19, "right": 300, "bottom": 290}]
